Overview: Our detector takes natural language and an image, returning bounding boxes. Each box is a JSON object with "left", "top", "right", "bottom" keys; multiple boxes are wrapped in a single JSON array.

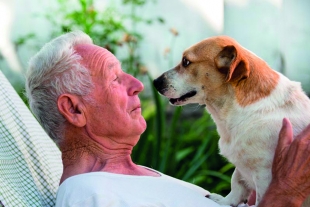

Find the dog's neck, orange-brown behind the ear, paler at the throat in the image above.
[{"left": 205, "top": 52, "right": 280, "bottom": 122}]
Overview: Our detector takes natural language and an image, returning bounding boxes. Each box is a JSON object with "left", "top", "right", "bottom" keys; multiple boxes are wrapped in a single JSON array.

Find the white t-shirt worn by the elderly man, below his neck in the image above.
[{"left": 56, "top": 167, "right": 232, "bottom": 207}]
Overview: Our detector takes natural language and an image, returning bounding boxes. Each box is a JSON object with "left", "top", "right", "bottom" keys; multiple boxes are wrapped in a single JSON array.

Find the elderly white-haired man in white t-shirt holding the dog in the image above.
[{"left": 26, "top": 31, "right": 310, "bottom": 207}]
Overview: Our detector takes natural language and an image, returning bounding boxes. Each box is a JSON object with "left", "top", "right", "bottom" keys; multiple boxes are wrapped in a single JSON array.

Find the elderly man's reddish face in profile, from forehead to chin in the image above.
[{"left": 76, "top": 44, "right": 146, "bottom": 144}]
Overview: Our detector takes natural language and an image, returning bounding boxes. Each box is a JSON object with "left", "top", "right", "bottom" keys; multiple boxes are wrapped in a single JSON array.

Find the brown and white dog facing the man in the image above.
[{"left": 154, "top": 36, "right": 310, "bottom": 206}]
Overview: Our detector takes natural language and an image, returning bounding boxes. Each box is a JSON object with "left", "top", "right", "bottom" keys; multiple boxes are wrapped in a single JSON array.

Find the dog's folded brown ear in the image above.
[{"left": 214, "top": 45, "right": 250, "bottom": 82}]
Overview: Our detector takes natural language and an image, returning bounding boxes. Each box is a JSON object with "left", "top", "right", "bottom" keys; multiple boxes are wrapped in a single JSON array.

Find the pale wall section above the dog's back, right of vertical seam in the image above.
[{"left": 224, "top": 0, "right": 310, "bottom": 93}]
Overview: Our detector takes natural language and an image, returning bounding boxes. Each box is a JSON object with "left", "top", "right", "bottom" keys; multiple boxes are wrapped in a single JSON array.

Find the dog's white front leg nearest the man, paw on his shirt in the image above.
[{"left": 208, "top": 168, "right": 250, "bottom": 206}]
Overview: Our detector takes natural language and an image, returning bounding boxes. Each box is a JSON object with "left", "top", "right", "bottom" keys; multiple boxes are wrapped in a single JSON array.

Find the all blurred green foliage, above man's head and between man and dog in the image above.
[{"left": 15, "top": 0, "right": 234, "bottom": 195}]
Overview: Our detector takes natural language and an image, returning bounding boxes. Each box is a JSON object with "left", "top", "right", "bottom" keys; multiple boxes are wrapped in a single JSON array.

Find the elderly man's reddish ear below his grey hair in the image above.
[{"left": 57, "top": 94, "right": 86, "bottom": 127}]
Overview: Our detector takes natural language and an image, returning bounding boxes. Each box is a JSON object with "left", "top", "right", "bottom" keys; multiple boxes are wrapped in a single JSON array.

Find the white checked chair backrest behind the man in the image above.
[{"left": 0, "top": 71, "right": 62, "bottom": 207}]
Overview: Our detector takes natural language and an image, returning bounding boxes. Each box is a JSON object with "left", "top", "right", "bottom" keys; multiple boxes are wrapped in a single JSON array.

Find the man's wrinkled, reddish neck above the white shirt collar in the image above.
[{"left": 60, "top": 137, "right": 159, "bottom": 183}]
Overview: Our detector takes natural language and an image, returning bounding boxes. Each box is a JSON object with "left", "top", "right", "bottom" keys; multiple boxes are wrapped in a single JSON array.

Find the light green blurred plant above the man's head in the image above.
[{"left": 46, "top": 0, "right": 163, "bottom": 76}]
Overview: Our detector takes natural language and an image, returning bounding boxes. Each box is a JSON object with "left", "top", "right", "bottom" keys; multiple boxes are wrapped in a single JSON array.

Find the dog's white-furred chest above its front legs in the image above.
[{"left": 216, "top": 106, "right": 282, "bottom": 172}]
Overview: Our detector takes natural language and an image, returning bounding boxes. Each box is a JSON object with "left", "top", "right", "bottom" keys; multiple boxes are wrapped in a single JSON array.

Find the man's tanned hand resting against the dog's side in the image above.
[{"left": 258, "top": 119, "right": 310, "bottom": 207}]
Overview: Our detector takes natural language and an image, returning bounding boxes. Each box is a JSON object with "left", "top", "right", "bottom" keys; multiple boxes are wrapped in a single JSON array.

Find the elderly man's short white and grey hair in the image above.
[{"left": 25, "top": 31, "right": 94, "bottom": 146}]
